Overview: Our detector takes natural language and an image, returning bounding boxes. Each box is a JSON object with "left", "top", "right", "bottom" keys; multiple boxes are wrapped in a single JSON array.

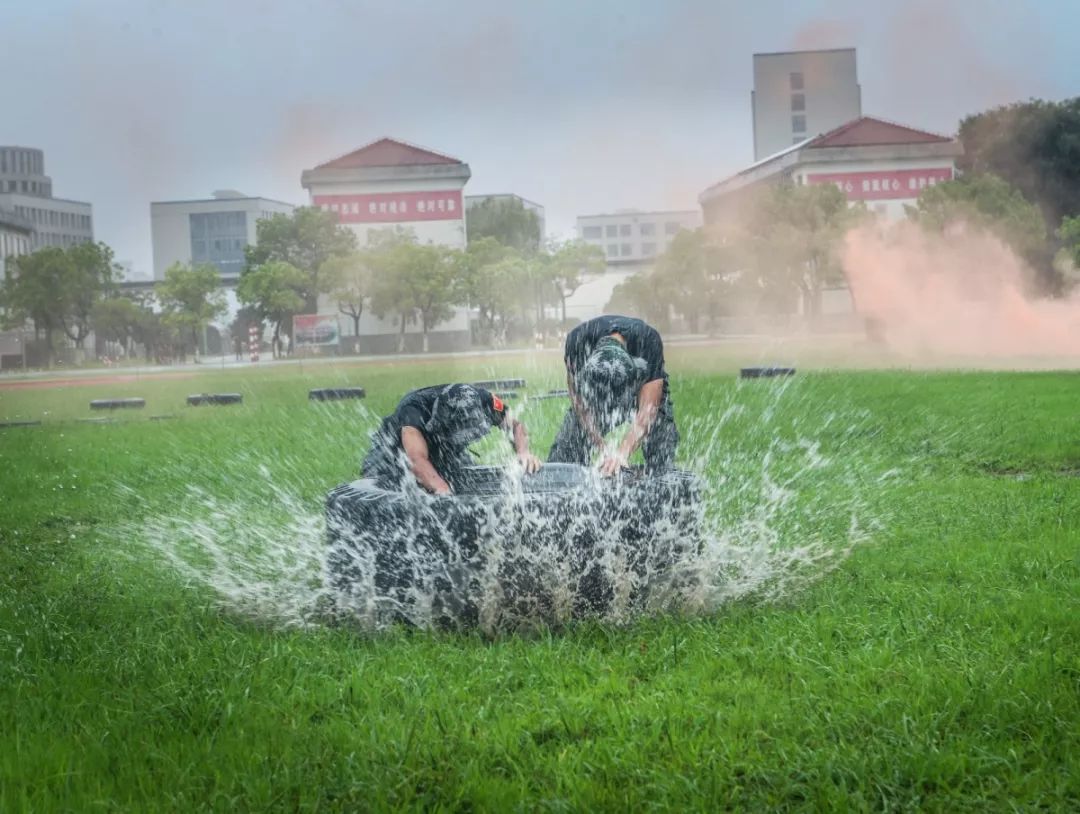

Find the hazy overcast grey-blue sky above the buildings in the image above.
[{"left": 8, "top": 0, "right": 1080, "bottom": 272}]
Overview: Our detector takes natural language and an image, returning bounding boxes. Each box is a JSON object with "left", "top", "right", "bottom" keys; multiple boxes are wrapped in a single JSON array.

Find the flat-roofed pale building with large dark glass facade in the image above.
[{"left": 150, "top": 190, "right": 295, "bottom": 283}]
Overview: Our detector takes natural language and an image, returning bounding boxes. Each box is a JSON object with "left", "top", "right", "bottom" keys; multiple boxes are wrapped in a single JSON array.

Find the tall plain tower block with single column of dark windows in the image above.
[{"left": 751, "top": 49, "right": 863, "bottom": 161}]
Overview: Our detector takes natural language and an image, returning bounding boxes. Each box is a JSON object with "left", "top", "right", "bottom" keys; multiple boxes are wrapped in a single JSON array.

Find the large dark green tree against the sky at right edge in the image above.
[{"left": 957, "top": 97, "right": 1080, "bottom": 230}]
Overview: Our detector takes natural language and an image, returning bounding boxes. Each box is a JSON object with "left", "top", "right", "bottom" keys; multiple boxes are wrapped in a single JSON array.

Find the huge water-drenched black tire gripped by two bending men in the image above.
[{"left": 326, "top": 464, "right": 702, "bottom": 628}]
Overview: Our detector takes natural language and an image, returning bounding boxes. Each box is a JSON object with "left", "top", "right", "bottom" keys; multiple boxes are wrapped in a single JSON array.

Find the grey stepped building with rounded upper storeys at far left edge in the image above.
[{"left": 0, "top": 147, "right": 94, "bottom": 252}]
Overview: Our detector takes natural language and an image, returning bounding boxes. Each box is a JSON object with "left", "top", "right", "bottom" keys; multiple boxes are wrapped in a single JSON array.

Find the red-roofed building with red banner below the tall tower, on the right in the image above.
[{"left": 698, "top": 116, "right": 962, "bottom": 225}]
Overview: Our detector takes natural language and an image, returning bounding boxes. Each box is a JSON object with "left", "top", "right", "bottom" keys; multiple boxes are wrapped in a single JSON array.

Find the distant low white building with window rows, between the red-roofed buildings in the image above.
[{"left": 578, "top": 209, "right": 701, "bottom": 268}]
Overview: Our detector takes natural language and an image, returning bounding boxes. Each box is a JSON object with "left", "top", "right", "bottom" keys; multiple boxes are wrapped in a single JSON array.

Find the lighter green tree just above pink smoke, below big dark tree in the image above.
[{"left": 907, "top": 174, "right": 1056, "bottom": 288}]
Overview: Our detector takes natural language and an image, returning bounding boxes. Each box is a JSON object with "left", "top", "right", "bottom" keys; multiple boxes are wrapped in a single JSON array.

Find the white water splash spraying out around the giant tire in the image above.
[{"left": 111, "top": 382, "right": 896, "bottom": 633}]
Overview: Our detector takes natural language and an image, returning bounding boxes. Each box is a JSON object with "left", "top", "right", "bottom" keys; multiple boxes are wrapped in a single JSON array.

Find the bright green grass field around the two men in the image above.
[{"left": 0, "top": 350, "right": 1080, "bottom": 812}]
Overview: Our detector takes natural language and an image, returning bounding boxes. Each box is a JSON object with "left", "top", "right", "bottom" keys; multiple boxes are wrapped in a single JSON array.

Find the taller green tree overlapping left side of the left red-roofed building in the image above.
[{"left": 241, "top": 206, "right": 356, "bottom": 313}]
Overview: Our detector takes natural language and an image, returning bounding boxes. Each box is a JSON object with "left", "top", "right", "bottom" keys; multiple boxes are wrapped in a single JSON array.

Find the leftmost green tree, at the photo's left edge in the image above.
[{"left": 0, "top": 247, "right": 75, "bottom": 366}]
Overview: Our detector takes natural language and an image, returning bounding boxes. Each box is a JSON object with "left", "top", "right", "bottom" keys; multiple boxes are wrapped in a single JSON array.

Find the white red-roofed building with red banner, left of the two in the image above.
[{"left": 300, "top": 138, "right": 471, "bottom": 353}]
